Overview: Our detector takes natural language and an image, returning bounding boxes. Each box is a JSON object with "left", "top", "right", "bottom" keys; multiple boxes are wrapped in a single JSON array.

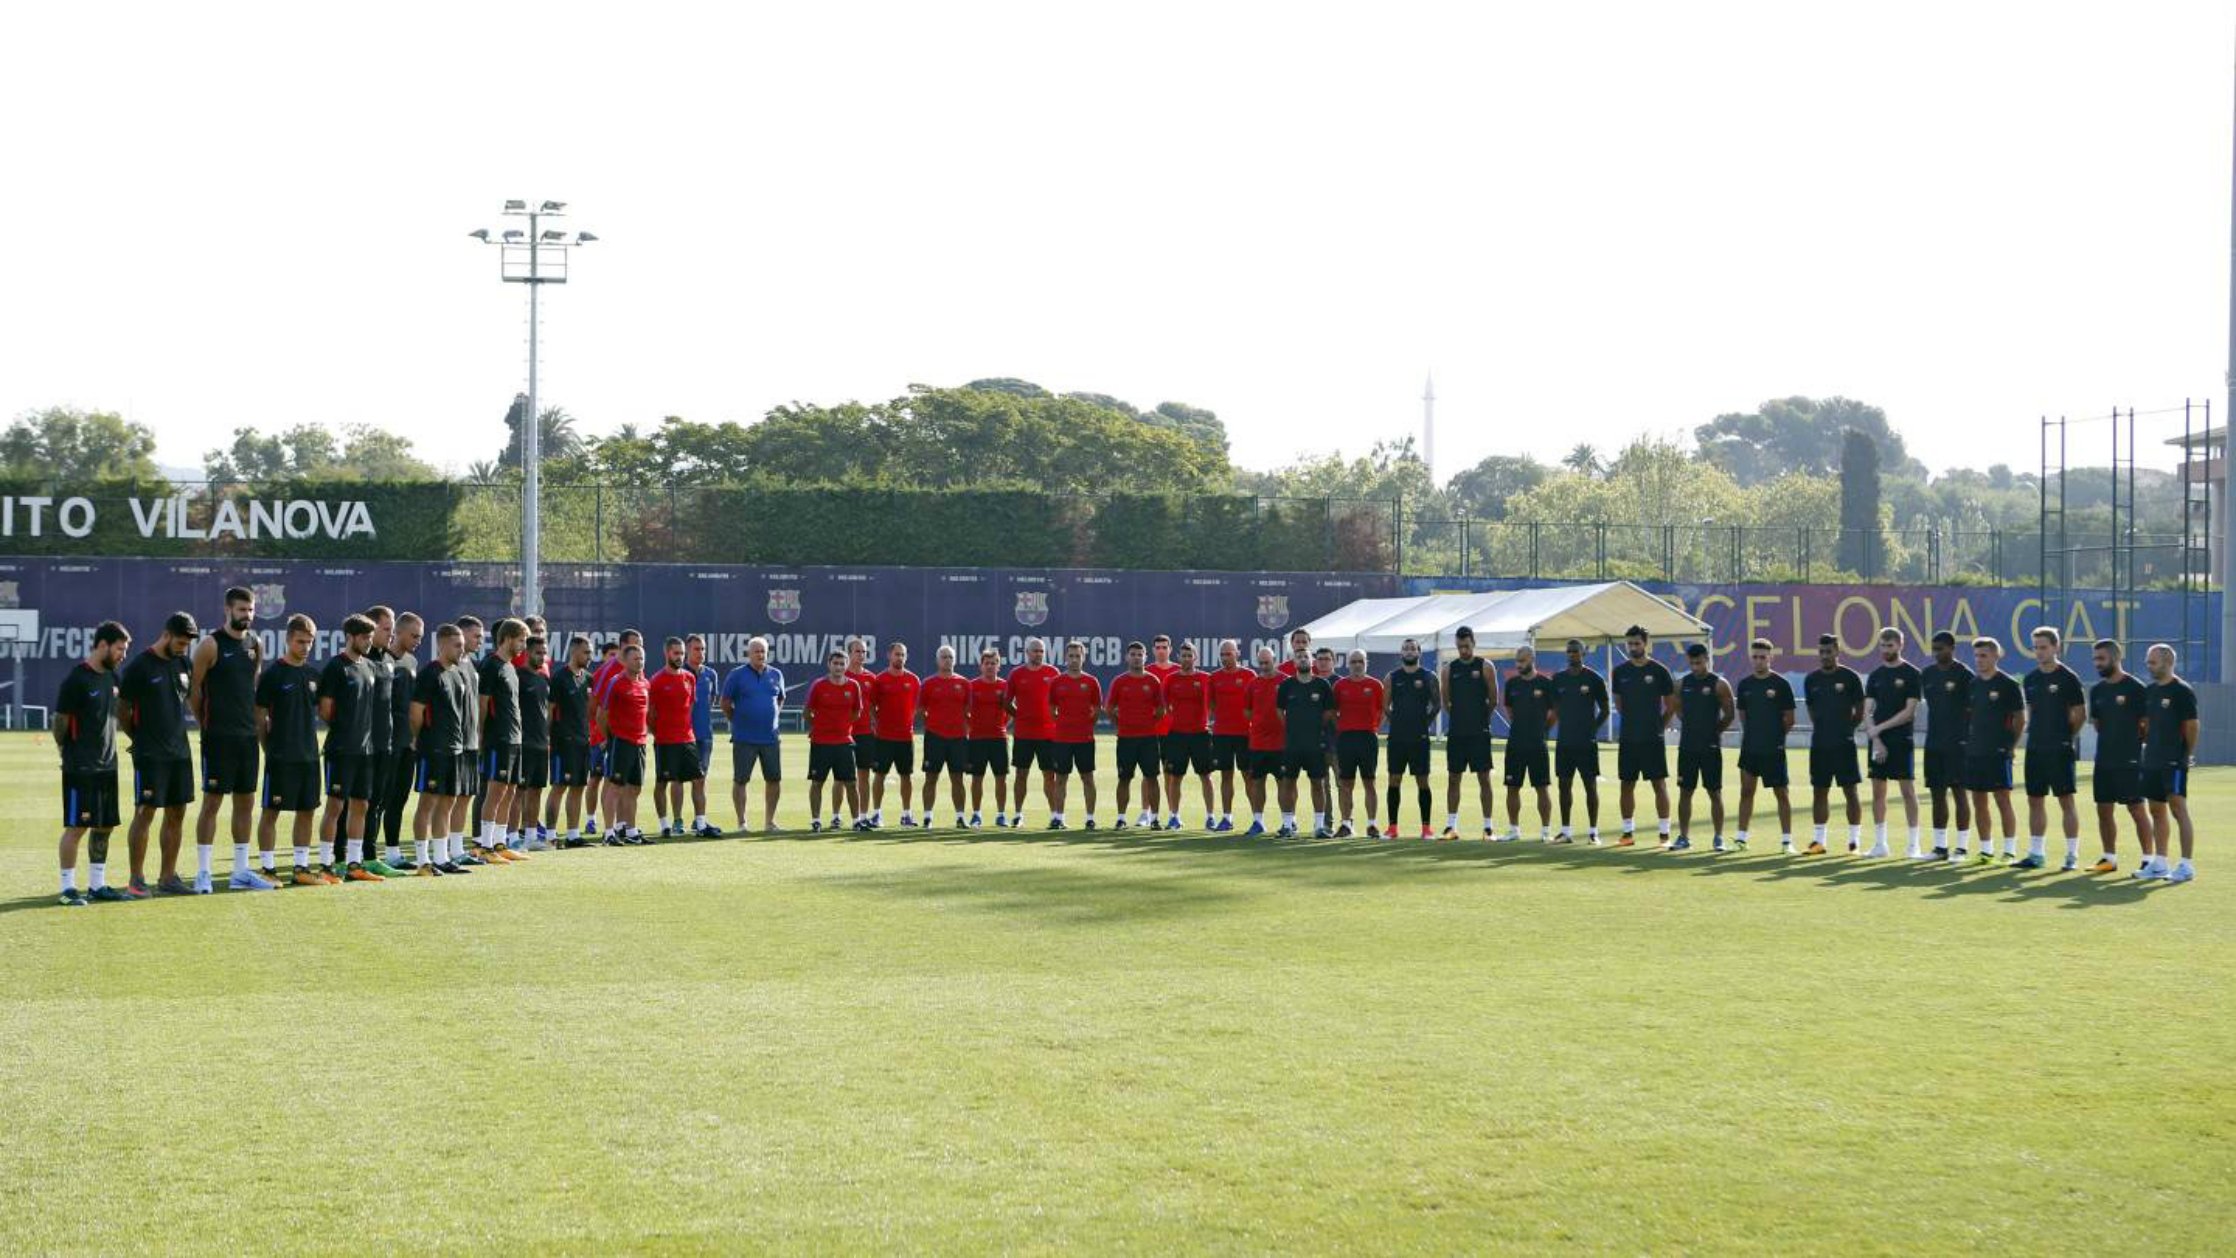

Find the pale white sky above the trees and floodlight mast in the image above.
[{"left": 0, "top": 2, "right": 2236, "bottom": 476}]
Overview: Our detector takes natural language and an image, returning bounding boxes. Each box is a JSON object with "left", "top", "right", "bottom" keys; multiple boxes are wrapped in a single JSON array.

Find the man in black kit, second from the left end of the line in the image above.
[{"left": 116, "top": 612, "right": 201, "bottom": 900}]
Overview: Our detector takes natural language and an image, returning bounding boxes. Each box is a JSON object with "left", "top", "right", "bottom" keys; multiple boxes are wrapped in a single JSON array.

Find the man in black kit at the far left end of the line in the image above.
[{"left": 54, "top": 621, "right": 132, "bottom": 907}]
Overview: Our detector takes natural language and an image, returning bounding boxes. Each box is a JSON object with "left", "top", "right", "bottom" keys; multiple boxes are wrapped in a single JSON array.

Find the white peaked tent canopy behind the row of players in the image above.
[{"left": 1304, "top": 581, "right": 1708, "bottom": 655}]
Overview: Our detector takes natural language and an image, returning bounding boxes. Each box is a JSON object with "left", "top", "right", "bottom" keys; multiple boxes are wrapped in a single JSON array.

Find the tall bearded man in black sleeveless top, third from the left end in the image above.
[{"left": 186, "top": 585, "right": 264, "bottom": 896}]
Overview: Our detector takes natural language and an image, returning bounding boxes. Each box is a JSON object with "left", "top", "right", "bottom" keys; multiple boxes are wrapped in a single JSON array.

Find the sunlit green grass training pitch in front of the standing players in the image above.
[{"left": 0, "top": 735, "right": 2236, "bottom": 1254}]
